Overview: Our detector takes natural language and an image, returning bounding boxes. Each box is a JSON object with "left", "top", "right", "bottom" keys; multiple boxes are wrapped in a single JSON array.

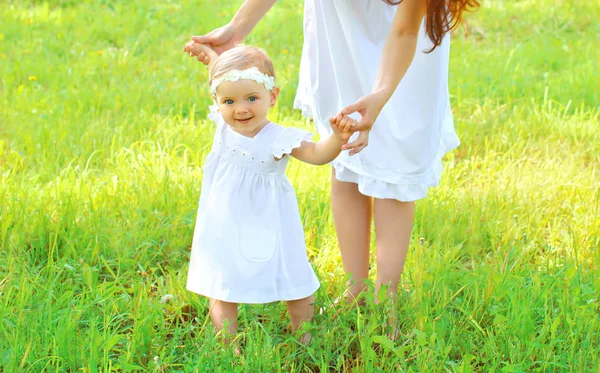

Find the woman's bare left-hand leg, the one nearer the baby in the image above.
[{"left": 331, "top": 169, "right": 373, "bottom": 301}]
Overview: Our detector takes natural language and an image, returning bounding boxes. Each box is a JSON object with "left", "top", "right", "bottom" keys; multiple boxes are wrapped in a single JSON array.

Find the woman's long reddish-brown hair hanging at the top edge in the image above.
[{"left": 383, "top": 0, "right": 479, "bottom": 53}]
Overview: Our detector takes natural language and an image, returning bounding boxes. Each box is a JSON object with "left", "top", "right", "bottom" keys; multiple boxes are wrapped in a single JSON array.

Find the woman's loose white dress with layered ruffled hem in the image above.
[{"left": 294, "top": 0, "right": 459, "bottom": 201}]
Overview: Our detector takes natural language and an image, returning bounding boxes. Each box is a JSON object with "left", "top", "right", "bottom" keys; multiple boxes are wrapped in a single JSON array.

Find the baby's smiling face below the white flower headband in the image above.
[{"left": 216, "top": 79, "right": 279, "bottom": 137}]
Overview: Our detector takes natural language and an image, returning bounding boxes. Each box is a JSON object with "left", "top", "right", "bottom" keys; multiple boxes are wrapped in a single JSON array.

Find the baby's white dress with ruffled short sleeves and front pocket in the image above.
[{"left": 187, "top": 107, "right": 319, "bottom": 303}]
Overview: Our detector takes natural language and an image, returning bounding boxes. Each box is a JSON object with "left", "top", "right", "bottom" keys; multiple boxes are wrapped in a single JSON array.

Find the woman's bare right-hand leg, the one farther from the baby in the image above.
[{"left": 374, "top": 198, "right": 415, "bottom": 299}]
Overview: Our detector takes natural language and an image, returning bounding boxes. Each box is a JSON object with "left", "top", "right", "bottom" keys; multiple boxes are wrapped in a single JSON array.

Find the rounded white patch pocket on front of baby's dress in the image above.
[{"left": 239, "top": 221, "right": 277, "bottom": 262}]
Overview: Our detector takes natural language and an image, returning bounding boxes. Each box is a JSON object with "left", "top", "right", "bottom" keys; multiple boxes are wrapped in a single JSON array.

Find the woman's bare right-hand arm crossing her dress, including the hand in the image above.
[{"left": 340, "top": 0, "right": 427, "bottom": 155}]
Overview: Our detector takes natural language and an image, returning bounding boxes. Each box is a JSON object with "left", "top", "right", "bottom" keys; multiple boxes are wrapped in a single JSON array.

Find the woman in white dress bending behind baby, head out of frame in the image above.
[{"left": 186, "top": 0, "right": 479, "bottom": 306}]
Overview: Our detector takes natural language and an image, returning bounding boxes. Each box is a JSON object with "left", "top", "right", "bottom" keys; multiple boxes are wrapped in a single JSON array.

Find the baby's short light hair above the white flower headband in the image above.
[{"left": 208, "top": 44, "right": 275, "bottom": 85}]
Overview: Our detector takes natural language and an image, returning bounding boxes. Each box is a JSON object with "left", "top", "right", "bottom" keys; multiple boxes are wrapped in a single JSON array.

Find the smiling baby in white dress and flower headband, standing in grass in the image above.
[{"left": 187, "top": 44, "right": 356, "bottom": 333}]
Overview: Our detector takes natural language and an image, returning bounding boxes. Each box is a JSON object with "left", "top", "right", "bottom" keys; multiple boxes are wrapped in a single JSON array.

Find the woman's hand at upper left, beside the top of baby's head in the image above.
[{"left": 183, "top": 23, "right": 244, "bottom": 65}]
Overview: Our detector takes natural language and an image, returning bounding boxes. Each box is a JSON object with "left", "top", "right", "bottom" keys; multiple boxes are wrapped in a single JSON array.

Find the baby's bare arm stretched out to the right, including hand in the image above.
[{"left": 292, "top": 115, "right": 356, "bottom": 165}]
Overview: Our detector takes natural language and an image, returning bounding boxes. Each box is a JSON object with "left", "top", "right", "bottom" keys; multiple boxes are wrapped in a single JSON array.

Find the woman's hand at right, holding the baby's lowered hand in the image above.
[{"left": 340, "top": 91, "right": 390, "bottom": 155}]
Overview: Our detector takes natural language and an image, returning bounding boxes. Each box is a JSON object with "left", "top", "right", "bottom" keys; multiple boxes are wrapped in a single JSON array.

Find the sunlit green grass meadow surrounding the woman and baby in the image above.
[{"left": 0, "top": 0, "right": 600, "bottom": 373}]
